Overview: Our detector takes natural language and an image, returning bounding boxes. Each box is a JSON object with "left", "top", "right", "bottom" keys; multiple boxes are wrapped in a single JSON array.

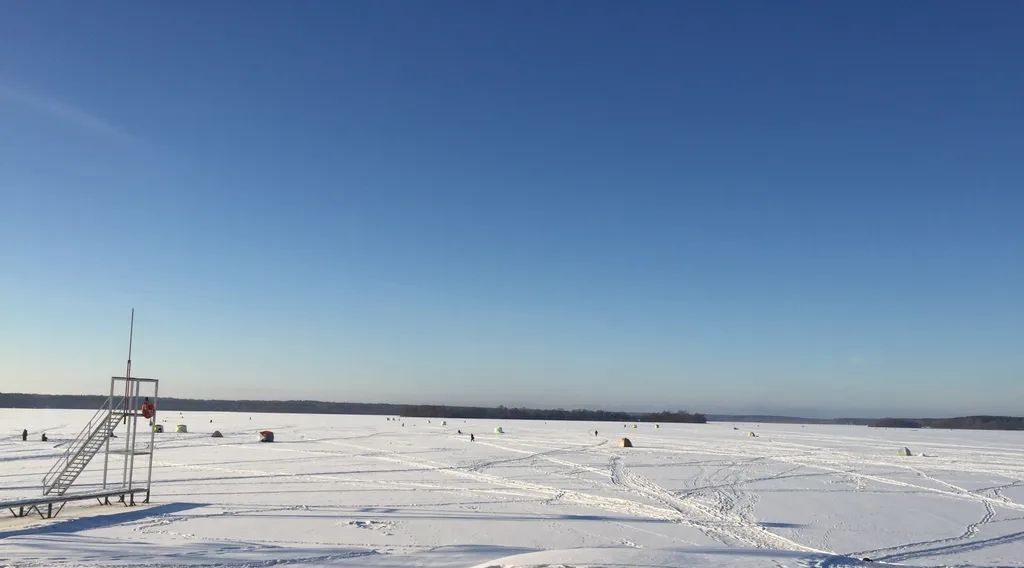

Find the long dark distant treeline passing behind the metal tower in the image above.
[{"left": 0, "top": 393, "right": 708, "bottom": 424}]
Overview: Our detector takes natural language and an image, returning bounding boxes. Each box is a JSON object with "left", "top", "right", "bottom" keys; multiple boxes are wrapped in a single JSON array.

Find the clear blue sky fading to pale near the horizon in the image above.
[{"left": 0, "top": 2, "right": 1024, "bottom": 416}]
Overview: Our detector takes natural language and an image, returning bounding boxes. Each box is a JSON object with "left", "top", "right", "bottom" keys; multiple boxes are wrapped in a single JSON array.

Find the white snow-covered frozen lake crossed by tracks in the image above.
[{"left": 0, "top": 409, "right": 1024, "bottom": 567}]
